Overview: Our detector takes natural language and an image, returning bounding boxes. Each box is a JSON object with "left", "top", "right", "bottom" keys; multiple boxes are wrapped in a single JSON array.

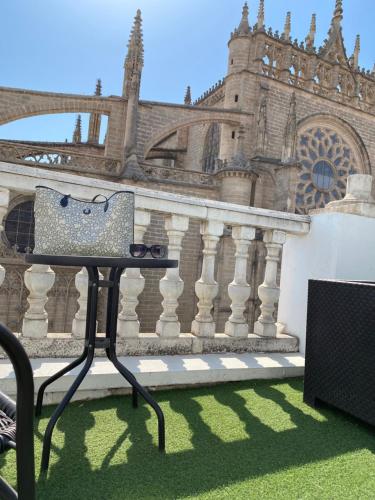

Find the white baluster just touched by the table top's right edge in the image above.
[{"left": 156, "top": 215, "right": 189, "bottom": 337}]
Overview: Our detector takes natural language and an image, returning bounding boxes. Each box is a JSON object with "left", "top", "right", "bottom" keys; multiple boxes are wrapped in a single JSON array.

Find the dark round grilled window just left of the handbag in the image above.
[{"left": 4, "top": 200, "right": 35, "bottom": 253}]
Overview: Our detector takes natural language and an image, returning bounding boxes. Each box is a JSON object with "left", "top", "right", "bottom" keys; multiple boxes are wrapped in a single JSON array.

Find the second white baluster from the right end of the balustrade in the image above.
[{"left": 225, "top": 226, "right": 255, "bottom": 337}]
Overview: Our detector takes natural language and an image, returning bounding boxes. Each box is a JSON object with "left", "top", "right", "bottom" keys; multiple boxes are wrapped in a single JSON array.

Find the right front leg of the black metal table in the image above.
[{"left": 106, "top": 268, "right": 165, "bottom": 451}]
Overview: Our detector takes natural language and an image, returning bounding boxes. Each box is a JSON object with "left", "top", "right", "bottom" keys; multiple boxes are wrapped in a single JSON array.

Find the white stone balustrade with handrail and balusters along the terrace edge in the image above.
[{"left": 0, "top": 162, "right": 309, "bottom": 356}]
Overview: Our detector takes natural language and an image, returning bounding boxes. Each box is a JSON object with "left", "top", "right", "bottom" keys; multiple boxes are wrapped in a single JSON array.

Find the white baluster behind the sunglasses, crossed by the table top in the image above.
[{"left": 117, "top": 210, "right": 151, "bottom": 337}]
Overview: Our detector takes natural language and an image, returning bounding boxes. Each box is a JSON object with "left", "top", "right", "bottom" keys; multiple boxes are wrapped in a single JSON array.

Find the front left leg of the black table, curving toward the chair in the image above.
[{"left": 41, "top": 267, "right": 99, "bottom": 471}]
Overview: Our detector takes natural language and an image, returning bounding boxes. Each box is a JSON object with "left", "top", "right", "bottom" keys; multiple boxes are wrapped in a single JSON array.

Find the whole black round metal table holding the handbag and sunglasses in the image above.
[{"left": 25, "top": 254, "right": 178, "bottom": 471}]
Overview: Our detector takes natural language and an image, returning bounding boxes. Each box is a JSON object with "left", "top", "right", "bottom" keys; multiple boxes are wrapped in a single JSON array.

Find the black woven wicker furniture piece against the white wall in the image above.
[{"left": 304, "top": 280, "right": 375, "bottom": 425}]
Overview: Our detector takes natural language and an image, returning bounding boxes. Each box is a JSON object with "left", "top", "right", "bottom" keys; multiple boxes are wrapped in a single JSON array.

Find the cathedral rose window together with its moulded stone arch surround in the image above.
[{"left": 296, "top": 114, "right": 371, "bottom": 213}]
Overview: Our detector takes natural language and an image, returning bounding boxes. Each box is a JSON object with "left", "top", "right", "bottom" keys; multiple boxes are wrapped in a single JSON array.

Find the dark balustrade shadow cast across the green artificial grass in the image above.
[{"left": 38, "top": 380, "right": 375, "bottom": 500}]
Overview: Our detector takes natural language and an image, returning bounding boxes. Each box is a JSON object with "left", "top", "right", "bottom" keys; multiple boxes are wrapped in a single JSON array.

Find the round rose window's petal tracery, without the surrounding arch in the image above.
[{"left": 296, "top": 127, "right": 358, "bottom": 213}]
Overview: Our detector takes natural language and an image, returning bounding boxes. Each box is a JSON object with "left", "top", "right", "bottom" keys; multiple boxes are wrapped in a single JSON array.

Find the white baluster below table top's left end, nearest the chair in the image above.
[{"left": 22, "top": 264, "right": 55, "bottom": 338}]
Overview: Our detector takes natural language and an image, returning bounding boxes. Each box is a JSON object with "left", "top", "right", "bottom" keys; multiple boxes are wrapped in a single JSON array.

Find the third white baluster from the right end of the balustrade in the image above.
[{"left": 191, "top": 220, "right": 224, "bottom": 337}]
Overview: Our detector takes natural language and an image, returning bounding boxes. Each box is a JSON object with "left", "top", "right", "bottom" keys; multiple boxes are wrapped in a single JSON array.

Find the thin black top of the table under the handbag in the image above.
[{"left": 25, "top": 253, "right": 178, "bottom": 269}]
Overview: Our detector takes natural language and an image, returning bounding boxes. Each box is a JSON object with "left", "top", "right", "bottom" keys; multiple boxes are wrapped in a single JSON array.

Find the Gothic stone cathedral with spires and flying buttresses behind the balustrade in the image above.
[{"left": 0, "top": 0, "right": 375, "bottom": 332}]
